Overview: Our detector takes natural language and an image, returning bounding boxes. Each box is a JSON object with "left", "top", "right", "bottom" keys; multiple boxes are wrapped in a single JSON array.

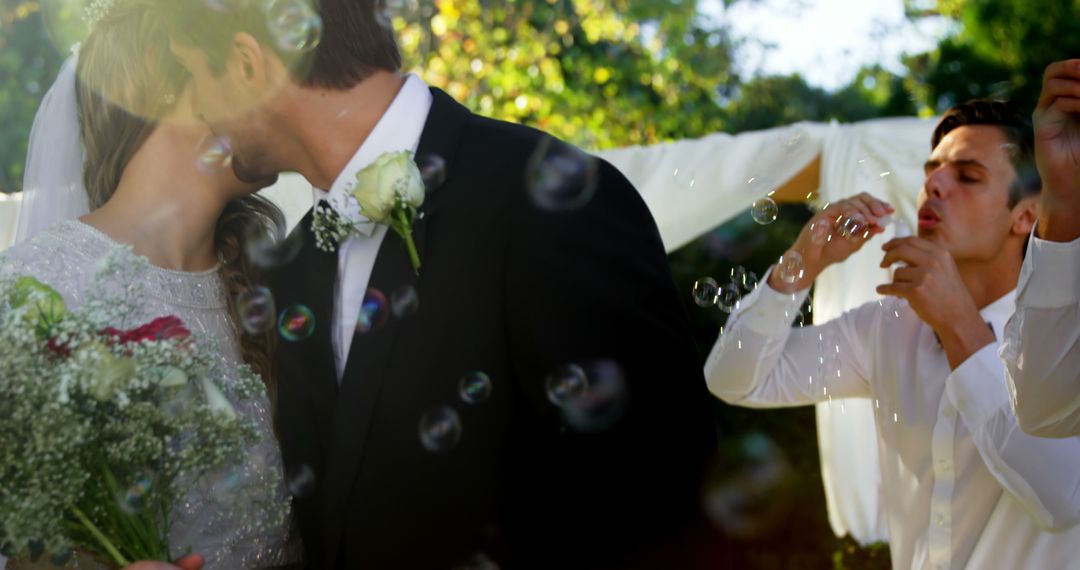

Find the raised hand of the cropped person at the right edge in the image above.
[{"left": 1032, "top": 59, "right": 1080, "bottom": 242}]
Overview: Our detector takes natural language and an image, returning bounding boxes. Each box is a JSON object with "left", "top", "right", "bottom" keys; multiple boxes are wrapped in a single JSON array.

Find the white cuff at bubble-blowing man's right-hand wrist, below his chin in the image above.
[{"left": 945, "top": 342, "right": 1009, "bottom": 431}]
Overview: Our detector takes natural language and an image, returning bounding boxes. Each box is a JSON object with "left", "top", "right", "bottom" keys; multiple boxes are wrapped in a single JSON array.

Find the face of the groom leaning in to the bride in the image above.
[{"left": 173, "top": 37, "right": 280, "bottom": 182}]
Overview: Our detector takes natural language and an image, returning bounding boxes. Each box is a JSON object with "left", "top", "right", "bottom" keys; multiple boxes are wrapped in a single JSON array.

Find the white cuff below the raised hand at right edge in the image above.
[{"left": 1016, "top": 224, "right": 1080, "bottom": 309}]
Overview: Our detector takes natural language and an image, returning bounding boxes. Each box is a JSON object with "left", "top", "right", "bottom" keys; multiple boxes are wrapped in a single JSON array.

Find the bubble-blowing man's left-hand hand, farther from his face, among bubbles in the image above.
[{"left": 769, "top": 192, "right": 893, "bottom": 293}]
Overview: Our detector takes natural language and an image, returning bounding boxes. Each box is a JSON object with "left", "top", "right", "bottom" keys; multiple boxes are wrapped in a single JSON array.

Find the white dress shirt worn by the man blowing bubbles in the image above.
[{"left": 705, "top": 273, "right": 1080, "bottom": 569}]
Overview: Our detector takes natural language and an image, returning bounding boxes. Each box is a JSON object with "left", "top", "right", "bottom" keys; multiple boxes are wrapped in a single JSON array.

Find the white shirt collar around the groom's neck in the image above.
[{"left": 312, "top": 73, "right": 433, "bottom": 236}]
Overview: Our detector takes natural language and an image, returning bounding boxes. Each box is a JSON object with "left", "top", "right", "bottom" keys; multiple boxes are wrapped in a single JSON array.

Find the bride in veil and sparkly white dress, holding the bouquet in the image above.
[{"left": 0, "top": 0, "right": 300, "bottom": 570}]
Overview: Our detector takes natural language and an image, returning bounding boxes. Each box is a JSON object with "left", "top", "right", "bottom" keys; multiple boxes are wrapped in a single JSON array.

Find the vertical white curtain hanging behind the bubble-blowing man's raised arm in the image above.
[{"left": 813, "top": 119, "right": 936, "bottom": 544}]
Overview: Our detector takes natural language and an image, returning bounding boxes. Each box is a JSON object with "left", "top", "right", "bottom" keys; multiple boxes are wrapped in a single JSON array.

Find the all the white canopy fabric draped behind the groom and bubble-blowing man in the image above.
[{"left": 0, "top": 113, "right": 935, "bottom": 552}]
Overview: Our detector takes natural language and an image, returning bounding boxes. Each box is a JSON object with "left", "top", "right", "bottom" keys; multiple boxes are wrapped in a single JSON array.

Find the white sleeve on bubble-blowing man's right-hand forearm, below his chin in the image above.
[{"left": 946, "top": 344, "right": 1080, "bottom": 531}]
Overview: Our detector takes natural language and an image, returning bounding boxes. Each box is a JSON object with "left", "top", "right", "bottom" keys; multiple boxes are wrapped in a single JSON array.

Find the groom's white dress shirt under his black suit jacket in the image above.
[{"left": 314, "top": 74, "right": 432, "bottom": 382}]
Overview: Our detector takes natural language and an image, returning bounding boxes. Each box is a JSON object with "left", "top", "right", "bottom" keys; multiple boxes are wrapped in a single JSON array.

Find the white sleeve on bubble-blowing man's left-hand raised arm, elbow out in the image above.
[{"left": 705, "top": 267, "right": 878, "bottom": 408}]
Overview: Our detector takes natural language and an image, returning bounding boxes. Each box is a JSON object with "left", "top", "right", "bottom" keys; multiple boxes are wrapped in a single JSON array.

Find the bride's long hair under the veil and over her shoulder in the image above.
[{"left": 76, "top": 0, "right": 284, "bottom": 401}]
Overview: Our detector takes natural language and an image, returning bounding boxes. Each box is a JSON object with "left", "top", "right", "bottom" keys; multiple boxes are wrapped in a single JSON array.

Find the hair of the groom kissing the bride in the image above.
[{"left": 162, "top": 0, "right": 402, "bottom": 90}]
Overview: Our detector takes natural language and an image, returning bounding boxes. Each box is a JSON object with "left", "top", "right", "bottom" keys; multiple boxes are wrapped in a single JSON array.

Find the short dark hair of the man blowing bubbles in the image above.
[{"left": 930, "top": 99, "right": 1042, "bottom": 208}]
